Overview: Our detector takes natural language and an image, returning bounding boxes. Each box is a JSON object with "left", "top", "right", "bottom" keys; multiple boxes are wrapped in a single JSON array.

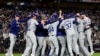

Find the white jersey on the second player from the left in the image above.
[{"left": 27, "top": 19, "right": 39, "bottom": 31}]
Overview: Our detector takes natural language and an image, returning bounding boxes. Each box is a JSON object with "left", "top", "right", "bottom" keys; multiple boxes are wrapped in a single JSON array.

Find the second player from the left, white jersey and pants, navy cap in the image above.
[{"left": 22, "top": 14, "right": 38, "bottom": 56}]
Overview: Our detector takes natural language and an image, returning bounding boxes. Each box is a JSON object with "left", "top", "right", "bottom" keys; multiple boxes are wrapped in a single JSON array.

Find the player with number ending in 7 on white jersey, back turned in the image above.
[{"left": 59, "top": 14, "right": 79, "bottom": 56}]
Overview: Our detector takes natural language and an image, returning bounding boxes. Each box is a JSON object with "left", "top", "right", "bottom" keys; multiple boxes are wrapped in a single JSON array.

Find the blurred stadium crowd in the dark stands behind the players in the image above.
[{"left": 0, "top": 8, "right": 100, "bottom": 52}]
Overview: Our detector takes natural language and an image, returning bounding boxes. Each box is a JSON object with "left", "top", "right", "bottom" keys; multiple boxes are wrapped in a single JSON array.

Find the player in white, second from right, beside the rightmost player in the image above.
[{"left": 77, "top": 13, "right": 90, "bottom": 56}]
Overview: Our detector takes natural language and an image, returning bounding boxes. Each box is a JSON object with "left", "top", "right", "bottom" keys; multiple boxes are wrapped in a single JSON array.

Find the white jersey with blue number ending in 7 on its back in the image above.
[{"left": 59, "top": 18, "right": 75, "bottom": 34}]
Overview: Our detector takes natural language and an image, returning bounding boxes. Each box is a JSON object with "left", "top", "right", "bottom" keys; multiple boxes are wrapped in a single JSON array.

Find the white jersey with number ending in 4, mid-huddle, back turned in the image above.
[{"left": 44, "top": 21, "right": 59, "bottom": 36}]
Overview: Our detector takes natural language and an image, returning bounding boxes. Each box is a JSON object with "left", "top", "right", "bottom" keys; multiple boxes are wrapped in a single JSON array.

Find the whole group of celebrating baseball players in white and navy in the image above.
[{"left": 5, "top": 10, "right": 94, "bottom": 56}]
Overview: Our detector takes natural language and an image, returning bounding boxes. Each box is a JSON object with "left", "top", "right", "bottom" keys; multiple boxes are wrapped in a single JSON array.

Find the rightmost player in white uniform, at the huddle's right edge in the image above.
[{"left": 81, "top": 13, "right": 94, "bottom": 55}]
